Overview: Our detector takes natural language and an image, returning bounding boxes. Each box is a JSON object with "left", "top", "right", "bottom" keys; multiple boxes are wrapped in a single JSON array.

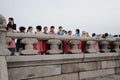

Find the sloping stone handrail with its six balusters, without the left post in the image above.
[{"left": 7, "top": 33, "right": 120, "bottom": 54}]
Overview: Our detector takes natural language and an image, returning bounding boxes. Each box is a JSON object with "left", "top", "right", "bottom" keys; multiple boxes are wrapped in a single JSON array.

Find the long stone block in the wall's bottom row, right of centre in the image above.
[{"left": 79, "top": 69, "right": 115, "bottom": 79}]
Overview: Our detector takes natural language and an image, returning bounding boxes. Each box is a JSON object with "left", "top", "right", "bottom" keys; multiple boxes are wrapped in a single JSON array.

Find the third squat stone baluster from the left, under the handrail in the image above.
[{"left": 69, "top": 40, "right": 81, "bottom": 54}]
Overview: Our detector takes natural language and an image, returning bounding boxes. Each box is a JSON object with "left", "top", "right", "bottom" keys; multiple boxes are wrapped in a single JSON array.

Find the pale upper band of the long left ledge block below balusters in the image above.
[{"left": 6, "top": 54, "right": 83, "bottom": 62}]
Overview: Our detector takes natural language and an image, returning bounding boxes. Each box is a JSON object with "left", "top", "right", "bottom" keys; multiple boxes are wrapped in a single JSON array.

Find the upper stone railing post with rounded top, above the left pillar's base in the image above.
[{"left": 0, "top": 15, "right": 11, "bottom": 55}]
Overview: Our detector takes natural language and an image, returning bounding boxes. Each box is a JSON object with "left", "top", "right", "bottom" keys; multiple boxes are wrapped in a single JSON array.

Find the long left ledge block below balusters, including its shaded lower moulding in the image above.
[{"left": 6, "top": 54, "right": 83, "bottom": 67}]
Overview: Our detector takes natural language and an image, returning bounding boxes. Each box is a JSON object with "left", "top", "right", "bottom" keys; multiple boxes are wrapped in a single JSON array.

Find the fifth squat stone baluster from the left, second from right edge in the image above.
[{"left": 100, "top": 40, "right": 110, "bottom": 53}]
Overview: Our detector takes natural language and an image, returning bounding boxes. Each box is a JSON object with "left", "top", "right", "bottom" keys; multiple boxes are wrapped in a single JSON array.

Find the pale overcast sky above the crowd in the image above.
[{"left": 0, "top": 0, "right": 120, "bottom": 34}]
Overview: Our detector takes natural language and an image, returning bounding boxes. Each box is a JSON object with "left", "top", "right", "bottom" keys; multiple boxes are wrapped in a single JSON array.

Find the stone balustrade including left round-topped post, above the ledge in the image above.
[{"left": 0, "top": 16, "right": 120, "bottom": 55}]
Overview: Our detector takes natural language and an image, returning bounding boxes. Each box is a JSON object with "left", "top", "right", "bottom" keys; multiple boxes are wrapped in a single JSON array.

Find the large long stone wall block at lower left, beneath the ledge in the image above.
[{"left": 8, "top": 65, "right": 61, "bottom": 80}]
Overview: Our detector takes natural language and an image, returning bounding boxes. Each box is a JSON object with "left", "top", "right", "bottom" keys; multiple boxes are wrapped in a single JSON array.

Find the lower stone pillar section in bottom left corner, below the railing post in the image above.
[{"left": 0, "top": 56, "right": 8, "bottom": 80}]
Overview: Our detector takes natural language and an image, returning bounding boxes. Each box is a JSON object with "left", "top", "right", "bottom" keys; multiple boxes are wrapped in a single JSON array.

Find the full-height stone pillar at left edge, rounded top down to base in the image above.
[{"left": 0, "top": 15, "right": 11, "bottom": 80}]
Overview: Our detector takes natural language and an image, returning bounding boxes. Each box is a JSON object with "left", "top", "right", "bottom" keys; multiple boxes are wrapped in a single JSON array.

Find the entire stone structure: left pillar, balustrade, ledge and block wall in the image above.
[{"left": 0, "top": 15, "right": 120, "bottom": 80}]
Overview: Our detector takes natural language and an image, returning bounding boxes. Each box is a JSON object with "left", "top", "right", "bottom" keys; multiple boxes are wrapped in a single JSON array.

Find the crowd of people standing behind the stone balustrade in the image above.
[{"left": 6, "top": 17, "right": 119, "bottom": 55}]
